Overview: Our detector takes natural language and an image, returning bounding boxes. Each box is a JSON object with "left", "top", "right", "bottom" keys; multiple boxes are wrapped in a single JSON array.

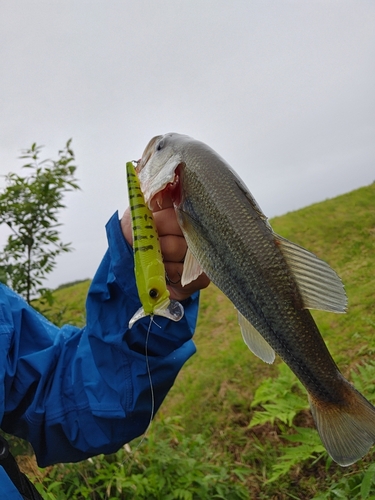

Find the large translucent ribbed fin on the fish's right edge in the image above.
[{"left": 275, "top": 235, "right": 347, "bottom": 313}]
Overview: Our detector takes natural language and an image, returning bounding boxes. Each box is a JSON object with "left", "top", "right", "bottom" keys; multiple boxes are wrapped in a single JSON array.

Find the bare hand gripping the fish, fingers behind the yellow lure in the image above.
[{"left": 121, "top": 197, "right": 210, "bottom": 301}]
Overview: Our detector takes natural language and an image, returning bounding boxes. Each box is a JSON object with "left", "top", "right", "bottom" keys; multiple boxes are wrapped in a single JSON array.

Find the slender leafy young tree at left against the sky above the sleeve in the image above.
[{"left": 0, "top": 139, "right": 79, "bottom": 302}]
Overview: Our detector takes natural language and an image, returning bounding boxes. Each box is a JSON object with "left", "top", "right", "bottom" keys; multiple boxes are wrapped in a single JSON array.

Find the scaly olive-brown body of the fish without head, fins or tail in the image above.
[{"left": 179, "top": 141, "right": 346, "bottom": 400}]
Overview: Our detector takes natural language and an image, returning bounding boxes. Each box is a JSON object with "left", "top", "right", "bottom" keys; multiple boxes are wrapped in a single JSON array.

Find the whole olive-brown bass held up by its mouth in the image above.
[{"left": 137, "top": 133, "right": 375, "bottom": 466}]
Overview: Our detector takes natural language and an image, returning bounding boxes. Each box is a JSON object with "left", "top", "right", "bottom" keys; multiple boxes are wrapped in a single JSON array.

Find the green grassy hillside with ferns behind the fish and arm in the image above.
[{"left": 12, "top": 184, "right": 375, "bottom": 500}]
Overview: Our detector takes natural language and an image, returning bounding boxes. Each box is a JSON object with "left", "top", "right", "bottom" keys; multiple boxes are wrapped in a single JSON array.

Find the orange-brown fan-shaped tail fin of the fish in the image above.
[{"left": 309, "top": 379, "right": 375, "bottom": 466}]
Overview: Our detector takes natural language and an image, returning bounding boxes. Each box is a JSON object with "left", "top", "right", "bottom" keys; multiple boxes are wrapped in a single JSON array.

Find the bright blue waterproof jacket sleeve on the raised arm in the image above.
[{"left": 0, "top": 214, "right": 199, "bottom": 466}]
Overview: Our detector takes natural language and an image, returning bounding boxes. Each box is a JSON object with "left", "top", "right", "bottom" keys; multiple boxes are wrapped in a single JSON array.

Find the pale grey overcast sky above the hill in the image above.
[{"left": 0, "top": 0, "right": 375, "bottom": 287}]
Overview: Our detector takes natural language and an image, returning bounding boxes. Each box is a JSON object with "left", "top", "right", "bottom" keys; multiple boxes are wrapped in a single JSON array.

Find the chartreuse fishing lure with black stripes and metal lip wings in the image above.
[{"left": 126, "top": 162, "right": 184, "bottom": 328}]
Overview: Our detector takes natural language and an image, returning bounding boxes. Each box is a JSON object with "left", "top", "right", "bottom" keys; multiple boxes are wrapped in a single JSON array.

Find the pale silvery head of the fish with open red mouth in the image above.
[{"left": 137, "top": 133, "right": 190, "bottom": 210}]
